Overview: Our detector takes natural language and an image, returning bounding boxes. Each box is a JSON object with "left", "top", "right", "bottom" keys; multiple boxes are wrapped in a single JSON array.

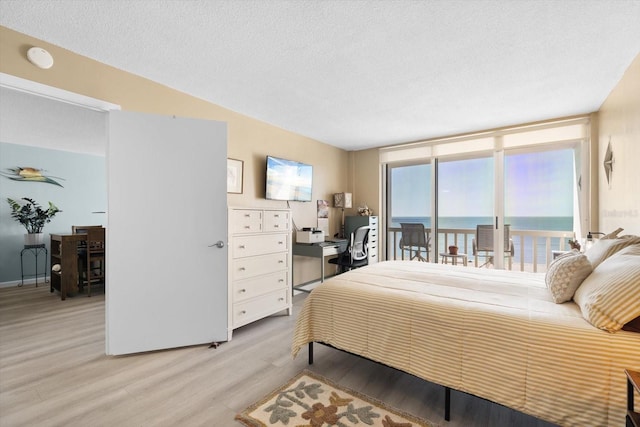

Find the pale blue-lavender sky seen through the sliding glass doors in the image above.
[{"left": 391, "top": 149, "right": 574, "bottom": 217}]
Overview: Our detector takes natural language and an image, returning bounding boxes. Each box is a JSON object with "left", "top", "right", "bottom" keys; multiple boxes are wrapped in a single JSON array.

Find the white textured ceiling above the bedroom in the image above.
[{"left": 0, "top": 0, "right": 640, "bottom": 150}]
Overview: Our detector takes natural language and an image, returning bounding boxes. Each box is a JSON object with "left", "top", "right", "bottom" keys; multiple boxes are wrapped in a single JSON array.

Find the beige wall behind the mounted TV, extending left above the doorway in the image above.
[{"left": 0, "top": 27, "right": 350, "bottom": 284}]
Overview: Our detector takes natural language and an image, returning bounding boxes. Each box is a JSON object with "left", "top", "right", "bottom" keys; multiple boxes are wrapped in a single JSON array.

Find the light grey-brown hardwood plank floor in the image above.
[{"left": 0, "top": 285, "right": 551, "bottom": 427}]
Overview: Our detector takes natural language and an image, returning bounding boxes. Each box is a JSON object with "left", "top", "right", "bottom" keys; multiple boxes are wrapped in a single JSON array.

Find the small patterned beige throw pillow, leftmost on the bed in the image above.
[{"left": 544, "top": 251, "right": 592, "bottom": 304}]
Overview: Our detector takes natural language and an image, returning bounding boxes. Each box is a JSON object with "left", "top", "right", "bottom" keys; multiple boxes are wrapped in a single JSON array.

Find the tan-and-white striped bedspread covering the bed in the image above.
[{"left": 292, "top": 261, "right": 640, "bottom": 426}]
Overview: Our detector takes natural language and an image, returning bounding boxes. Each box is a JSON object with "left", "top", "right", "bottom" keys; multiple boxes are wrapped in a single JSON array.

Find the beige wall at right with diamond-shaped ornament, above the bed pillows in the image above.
[{"left": 596, "top": 55, "right": 640, "bottom": 235}]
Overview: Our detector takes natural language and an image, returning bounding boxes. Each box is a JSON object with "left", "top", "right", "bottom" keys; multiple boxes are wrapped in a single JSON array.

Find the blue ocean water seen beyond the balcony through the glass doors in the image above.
[{"left": 391, "top": 217, "right": 573, "bottom": 264}]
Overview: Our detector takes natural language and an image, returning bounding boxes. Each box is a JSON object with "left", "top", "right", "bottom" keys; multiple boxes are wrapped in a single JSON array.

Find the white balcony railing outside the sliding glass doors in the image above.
[{"left": 387, "top": 228, "right": 574, "bottom": 273}]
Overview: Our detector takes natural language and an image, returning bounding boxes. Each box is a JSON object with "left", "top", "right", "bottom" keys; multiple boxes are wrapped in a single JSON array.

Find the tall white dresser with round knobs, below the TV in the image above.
[{"left": 228, "top": 208, "right": 292, "bottom": 340}]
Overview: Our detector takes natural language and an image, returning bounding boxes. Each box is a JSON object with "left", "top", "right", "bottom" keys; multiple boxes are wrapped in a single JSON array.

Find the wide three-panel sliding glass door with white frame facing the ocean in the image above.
[{"left": 380, "top": 117, "right": 594, "bottom": 272}]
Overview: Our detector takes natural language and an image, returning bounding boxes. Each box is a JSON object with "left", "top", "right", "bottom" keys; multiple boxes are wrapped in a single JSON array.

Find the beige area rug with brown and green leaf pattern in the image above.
[{"left": 236, "top": 370, "right": 433, "bottom": 427}]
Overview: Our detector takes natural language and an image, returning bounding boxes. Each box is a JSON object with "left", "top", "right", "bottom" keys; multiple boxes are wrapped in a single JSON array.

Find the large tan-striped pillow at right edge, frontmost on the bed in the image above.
[{"left": 573, "top": 243, "right": 640, "bottom": 332}]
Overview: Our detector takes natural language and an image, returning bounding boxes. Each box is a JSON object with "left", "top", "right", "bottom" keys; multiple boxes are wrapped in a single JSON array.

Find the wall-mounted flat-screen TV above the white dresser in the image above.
[{"left": 265, "top": 156, "right": 313, "bottom": 202}]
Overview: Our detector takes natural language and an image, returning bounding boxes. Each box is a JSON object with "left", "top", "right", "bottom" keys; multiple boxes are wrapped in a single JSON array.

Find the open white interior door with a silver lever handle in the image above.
[{"left": 106, "top": 111, "right": 227, "bottom": 355}]
